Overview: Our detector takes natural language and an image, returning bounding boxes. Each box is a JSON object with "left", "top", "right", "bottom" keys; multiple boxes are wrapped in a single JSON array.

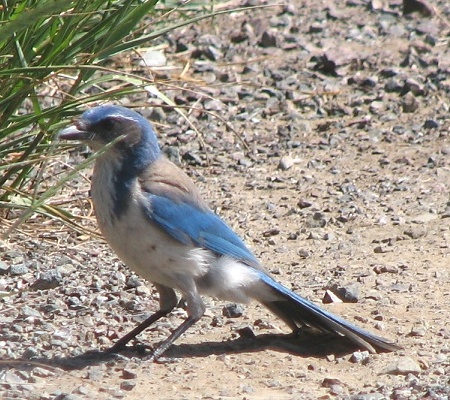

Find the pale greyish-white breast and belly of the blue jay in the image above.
[{"left": 91, "top": 159, "right": 204, "bottom": 287}]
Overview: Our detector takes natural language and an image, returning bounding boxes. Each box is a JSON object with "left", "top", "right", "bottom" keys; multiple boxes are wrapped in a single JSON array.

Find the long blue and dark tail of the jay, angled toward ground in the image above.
[{"left": 261, "top": 274, "right": 401, "bottom": 353}]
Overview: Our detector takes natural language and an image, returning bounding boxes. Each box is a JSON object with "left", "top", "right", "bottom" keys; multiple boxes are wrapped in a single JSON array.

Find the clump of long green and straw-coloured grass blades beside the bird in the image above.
[{"left": 0, "top": 0, "right": 229, "bottom": 236}]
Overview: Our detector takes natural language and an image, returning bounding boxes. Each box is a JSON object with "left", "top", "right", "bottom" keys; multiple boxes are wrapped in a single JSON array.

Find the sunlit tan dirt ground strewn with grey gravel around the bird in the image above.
[{"left": 0, "top": 0, "right": 450, "bottom": 400}]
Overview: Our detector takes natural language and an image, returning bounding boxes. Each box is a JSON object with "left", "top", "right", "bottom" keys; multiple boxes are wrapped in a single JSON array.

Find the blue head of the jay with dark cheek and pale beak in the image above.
[{"left": 59, "top": 105, "right": 160, "bottom": 167}]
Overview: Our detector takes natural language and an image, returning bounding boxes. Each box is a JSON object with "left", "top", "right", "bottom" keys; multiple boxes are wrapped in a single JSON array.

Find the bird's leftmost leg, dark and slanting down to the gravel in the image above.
[{"left": 108, "top": 285, "right": 178, "bottom": 353}]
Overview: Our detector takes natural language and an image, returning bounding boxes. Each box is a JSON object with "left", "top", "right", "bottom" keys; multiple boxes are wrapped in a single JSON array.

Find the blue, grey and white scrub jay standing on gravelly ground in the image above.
[{"left": 59, "top": 104, "right": 401, "bottom": 361}]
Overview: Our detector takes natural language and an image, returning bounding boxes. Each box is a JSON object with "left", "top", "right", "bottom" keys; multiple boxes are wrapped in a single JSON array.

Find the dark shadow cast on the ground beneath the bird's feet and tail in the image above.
[{"left": 0, "top": 334, "right": 357, "bottom": 371}]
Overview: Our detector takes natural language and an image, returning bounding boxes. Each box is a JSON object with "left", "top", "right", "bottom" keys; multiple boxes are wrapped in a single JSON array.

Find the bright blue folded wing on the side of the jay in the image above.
[{"left": 144, "top": 195, "right": 259, "bottom": 266}]
